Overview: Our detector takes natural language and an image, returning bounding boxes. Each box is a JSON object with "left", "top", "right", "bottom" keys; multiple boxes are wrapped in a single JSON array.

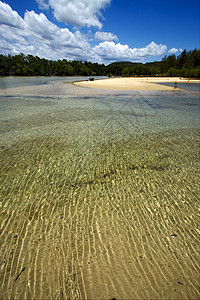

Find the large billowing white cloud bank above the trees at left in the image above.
[{"left": 0, "top": 1, "right": 90, "bottom": 60}]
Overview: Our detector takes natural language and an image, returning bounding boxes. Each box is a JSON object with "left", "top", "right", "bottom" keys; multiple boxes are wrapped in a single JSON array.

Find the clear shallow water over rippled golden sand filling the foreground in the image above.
[{"left": 0, "top": 79, "right": 200, "bottom": 299}]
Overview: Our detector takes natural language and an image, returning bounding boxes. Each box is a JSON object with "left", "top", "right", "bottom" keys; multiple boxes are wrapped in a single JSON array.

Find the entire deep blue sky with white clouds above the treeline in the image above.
[{"left": 0, "top": 0, "right": 200, "bottom": 64}]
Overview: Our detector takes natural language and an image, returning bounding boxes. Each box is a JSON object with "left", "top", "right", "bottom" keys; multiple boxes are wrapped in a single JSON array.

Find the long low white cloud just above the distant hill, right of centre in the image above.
[{"left": 95, "top": 41, "right": 167, "bottom": 61}]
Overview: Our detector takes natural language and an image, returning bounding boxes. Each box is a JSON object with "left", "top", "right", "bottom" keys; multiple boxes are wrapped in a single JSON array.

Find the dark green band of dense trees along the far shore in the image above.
[{"left": 0, "top": 49, "right": 200, "bottom": 78}]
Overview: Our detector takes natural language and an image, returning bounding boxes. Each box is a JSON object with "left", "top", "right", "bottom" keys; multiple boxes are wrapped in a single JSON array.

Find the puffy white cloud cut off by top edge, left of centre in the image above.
[{"left": 36, "top": 0, "right": 111, "bottom": 28}]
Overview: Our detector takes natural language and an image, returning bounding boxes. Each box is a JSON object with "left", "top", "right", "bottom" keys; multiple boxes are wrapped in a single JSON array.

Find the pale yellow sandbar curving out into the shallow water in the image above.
[{"left": 74, "top": 77, "right": 200, "bottom": 91}]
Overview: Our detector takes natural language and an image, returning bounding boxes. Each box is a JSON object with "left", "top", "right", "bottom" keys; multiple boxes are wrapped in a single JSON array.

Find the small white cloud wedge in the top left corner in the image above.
[{"left": 0, "top": 1, "right": 24, "bottom": 28}]
